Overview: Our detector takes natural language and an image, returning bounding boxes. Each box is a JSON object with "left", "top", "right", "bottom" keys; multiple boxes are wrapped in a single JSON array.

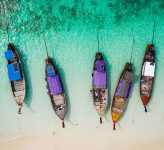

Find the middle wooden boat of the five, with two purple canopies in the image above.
[{"left": 91, "top": 52, "right": 108, "bottom": 123}]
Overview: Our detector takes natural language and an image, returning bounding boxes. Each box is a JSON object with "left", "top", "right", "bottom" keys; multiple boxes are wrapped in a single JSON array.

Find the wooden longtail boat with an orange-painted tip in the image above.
[{"left": 111, "top": 63, "right": 134, "bottom": 130}]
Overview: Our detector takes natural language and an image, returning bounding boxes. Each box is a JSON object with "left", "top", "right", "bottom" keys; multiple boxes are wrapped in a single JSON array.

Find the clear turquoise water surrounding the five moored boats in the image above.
[{"left": 0, "top": 0, "right": 164, "bottom": 140}]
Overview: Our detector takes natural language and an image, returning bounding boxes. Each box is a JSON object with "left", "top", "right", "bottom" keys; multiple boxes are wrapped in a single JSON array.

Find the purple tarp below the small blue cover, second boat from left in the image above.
[{"left": 47, "top": 75, "right": 62, "bottom": 95}]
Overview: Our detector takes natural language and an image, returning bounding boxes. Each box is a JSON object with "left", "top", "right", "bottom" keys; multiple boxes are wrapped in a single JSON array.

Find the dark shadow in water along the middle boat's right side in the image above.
[{"left": 103, "top": 54, "right": 112, "bottom": 122}]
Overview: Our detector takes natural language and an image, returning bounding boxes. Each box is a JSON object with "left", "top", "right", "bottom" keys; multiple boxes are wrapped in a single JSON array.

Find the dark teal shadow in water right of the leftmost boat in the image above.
[{"left": 17, "top": 46, "right": 34, "bottom": 112}]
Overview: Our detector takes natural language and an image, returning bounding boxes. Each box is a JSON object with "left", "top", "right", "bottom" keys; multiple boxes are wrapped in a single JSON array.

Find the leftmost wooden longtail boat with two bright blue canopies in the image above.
[{"left": 5, "top": 43, "right": 26, "bottom": 114}]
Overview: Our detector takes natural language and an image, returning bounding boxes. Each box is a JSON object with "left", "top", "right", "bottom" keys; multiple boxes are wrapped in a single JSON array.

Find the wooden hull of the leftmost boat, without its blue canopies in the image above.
[{"left": 7, "top": 43, "right": 26, "bottom": 114}]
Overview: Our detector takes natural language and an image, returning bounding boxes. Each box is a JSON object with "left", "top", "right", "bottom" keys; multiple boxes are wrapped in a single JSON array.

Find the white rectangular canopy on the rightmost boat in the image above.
[{"left": 142, "top": 62, "right": 155, "bottom": 77}]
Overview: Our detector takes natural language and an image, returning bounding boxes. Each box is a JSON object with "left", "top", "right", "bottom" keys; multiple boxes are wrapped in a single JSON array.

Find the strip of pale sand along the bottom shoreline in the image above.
[{"left": 0, "top": 135, "right": 164, "bottom": 150}]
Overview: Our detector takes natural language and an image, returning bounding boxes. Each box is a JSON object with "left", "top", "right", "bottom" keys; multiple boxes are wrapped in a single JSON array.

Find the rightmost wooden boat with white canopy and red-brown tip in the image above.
[{"left": 140, "top": 44, "right": 156, "bottom": 112}]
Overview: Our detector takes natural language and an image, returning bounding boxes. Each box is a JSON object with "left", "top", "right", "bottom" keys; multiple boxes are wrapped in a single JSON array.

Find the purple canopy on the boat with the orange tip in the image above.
[{"left": 115, "top": 79, "right": 132, "bottom": 99}]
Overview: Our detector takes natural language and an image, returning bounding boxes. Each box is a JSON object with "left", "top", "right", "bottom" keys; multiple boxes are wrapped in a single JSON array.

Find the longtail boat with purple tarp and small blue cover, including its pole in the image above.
[{"left": 44, "top": 36, "right": 66, "bottom": 128}]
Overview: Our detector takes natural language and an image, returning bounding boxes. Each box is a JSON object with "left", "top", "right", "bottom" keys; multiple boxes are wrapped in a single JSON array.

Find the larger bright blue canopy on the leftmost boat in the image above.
[{"left": 7, "top": 62, "right": 21, "bottom": 81}]
